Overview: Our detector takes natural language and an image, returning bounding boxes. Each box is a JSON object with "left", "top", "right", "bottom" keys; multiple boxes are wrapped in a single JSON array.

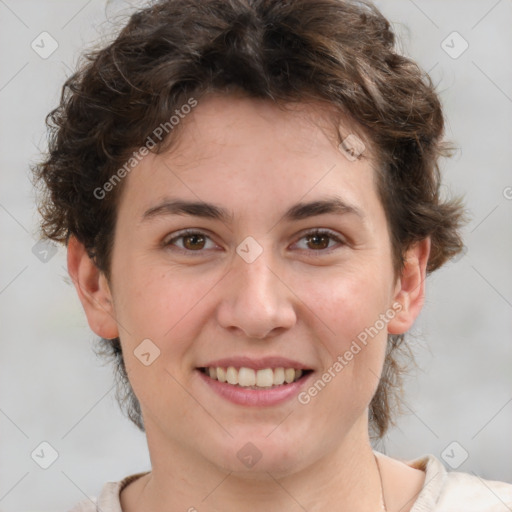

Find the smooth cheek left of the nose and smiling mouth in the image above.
[{"left": 115, "top": 261, "right": 207, "bottom": 424}]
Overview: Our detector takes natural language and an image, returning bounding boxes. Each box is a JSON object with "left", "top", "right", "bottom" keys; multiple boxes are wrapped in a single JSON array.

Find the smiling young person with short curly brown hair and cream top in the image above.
[{"left": 36, "top": 0, "right": 512, "bottom": 512}]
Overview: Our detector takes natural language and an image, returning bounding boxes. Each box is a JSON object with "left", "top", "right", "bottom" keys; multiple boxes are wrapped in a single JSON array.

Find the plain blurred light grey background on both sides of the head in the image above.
[{"left": 0, "top": 0, "right": 512, "bottom": 512}]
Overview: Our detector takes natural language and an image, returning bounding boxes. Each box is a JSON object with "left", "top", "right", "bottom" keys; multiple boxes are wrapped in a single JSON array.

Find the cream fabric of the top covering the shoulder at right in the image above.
[{"left": 407, "top": 454, "right": 512, "bottom": 512}]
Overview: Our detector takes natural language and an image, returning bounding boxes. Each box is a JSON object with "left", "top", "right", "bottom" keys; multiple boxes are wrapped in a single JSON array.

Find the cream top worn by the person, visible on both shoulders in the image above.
[{"left": 70, "top": 452, "right": 512, "bottom": 512}]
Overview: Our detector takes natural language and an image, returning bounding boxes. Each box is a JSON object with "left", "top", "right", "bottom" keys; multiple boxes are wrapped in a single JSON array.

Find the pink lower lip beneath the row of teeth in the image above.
[{"left": 196, "top": 370, "right": 312, "bottom": 407}]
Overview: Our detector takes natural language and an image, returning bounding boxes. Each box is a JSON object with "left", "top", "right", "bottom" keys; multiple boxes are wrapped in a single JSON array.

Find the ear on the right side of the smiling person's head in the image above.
[{"left": 388, "top": 238, "right": 430, "bottom": 334}]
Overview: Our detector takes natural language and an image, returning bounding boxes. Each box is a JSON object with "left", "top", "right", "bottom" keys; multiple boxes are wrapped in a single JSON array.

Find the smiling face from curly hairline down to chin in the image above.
[{"left": 70, "top": 95, "right": 426, "bottom": 475}]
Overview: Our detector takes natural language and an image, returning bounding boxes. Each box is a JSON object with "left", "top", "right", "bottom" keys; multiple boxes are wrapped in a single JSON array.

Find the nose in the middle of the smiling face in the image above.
[{"left": 217, "top": 250, "right": 296, "bottom": 339}]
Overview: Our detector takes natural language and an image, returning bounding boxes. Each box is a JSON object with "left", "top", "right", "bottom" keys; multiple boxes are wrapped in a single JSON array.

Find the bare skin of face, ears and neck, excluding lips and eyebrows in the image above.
[{"left": 68, "top": 95, "right": 430, "bottom": 512}]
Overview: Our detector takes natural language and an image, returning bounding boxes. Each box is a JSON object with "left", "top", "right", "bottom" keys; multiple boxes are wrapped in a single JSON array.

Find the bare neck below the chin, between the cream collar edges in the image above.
[{"left": 121, "top": 416, "right": 381, "bottom": 512}]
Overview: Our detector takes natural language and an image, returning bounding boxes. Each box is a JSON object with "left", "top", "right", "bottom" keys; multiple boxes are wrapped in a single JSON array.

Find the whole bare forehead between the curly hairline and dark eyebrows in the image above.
[{"left": 116, "top": 94, "right": 375, "bottom": 224}]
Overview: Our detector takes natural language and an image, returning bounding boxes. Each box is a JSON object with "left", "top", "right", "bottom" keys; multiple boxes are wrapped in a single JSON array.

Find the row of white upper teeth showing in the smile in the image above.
[{"left": 201, "top": 366, "right": 303, "bottom": 388}]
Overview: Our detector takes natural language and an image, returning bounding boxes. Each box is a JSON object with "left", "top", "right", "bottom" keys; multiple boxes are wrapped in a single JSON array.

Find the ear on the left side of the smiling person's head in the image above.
[{"left": 68, "top": 236, "right": 119, "bottom": 339}]
